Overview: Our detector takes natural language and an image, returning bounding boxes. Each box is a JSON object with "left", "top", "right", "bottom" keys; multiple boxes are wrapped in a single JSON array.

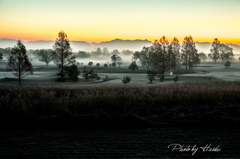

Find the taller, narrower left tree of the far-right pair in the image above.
[{"left": 208, "top": 38, "right": 221, "bottom": 64}]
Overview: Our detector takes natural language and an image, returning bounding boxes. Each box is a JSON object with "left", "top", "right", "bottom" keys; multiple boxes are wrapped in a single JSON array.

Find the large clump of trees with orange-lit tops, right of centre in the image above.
[{"left": 132, "top": 36, "right": 200, "bottom": 80}]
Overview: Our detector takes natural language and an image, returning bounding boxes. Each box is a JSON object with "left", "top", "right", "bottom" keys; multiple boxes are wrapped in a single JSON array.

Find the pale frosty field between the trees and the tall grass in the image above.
[{"left": 0, "top": 61, "right": 240, "bottom": 85}]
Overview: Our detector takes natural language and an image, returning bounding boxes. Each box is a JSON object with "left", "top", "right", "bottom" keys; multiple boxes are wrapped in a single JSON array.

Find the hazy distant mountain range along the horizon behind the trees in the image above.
[{"left": 0, "top": 39, "right": 240, "bottom": 54}]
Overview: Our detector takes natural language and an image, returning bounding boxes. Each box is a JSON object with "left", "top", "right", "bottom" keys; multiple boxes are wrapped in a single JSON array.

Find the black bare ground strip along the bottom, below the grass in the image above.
[{"left": 0, "top": 126, "right": 240, "bottom": 159}]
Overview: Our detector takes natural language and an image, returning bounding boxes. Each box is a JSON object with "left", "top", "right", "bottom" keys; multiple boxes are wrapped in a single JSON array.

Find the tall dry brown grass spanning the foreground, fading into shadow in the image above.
[{"left": 0, "top": 82, "right": 240, "bottom": 125}]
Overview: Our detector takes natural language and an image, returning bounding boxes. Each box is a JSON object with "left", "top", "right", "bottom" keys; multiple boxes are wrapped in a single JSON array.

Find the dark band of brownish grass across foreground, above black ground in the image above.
[{"left": 0, "top": 82, "right": 240, "bottom": 127}]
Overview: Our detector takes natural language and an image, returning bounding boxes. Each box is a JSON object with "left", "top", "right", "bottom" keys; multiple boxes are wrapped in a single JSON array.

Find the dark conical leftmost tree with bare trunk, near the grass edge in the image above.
[{"left": 7, "top": 40, "right": 33, "bottom": 86}]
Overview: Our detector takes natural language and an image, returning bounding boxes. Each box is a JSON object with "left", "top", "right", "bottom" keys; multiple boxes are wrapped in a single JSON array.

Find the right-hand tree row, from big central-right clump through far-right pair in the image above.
[{"left": 131, "top": 35, "right": 234, "bottom": 80}]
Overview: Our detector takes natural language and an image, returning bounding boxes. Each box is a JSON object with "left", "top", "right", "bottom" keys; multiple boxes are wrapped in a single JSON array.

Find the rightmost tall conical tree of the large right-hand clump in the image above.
[{"left": 182, "top": 35, "right": 200, "bottom": 70}]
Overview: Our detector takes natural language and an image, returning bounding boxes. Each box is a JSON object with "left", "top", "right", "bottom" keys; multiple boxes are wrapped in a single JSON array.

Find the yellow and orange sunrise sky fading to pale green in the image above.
[{"left": 0, "top": 0, "right": 240, "bottom": 45}]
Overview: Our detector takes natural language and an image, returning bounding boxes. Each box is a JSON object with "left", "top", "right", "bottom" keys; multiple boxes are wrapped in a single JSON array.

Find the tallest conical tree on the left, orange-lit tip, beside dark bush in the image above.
[{"left": 53, "top": 31, "right": 76, "bottom": 81}]
